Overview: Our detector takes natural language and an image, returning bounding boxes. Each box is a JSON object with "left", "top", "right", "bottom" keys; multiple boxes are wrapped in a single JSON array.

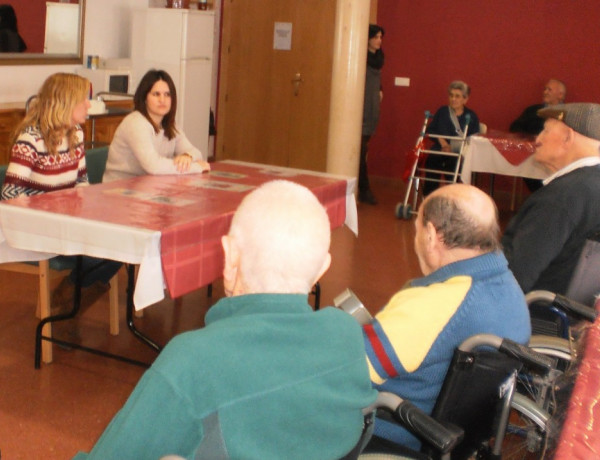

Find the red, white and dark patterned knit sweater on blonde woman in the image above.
[{"left": 1, "top": 127, "right": 88, "bottom": 200}]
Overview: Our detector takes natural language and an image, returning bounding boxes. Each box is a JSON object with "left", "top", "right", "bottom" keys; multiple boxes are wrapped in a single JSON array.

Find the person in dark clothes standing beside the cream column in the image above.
[{"left": 358, "top": 24, "right": 385, "bottom": 205}]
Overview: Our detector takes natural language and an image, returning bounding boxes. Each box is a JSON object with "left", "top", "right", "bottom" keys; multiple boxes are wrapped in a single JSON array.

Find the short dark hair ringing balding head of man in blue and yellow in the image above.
[{"left": 422, "top": 195, "right": 500, "bottom": 252}]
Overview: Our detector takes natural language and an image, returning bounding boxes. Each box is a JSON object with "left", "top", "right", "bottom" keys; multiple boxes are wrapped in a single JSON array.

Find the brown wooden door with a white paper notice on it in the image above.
[{"left": 216, "top": 0, "right": 336, "bottom": 171}]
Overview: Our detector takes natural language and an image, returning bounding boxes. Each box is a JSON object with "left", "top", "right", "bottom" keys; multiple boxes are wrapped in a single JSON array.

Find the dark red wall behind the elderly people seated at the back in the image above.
[{"left": 369, "top": 0, "right": 600, "bottom": 177}]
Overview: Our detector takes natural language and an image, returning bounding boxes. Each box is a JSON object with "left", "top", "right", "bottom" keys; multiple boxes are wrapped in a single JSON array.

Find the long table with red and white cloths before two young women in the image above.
[{"left": 0, "top": 161, "right": 357, "bottom": 365}]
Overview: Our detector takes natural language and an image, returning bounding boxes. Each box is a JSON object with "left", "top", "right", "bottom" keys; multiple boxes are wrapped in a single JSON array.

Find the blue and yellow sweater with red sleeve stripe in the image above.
[{"left": 363, "top": 252, "right": 531, "bottom": 448}]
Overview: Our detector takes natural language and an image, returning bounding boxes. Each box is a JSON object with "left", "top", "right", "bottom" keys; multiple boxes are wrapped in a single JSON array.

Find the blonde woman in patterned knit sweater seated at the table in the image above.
[{"left": 2, "top": 73, "right": 121, "bottom": 313}]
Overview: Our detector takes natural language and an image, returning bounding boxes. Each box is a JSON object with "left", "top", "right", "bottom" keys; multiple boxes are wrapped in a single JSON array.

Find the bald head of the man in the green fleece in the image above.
[{"left": 223, "top": 180, "right": 331, "bottom": 295}]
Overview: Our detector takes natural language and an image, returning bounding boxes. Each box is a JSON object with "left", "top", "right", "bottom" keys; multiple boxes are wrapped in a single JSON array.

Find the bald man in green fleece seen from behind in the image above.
[{"left": 77, "top": 181, "right": 377, "bottom": 460}]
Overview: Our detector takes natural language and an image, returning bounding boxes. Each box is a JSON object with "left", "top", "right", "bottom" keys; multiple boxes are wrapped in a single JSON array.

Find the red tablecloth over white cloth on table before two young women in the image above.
[{"left": 0, "top": 162, "right": 348, "bottom": 297}]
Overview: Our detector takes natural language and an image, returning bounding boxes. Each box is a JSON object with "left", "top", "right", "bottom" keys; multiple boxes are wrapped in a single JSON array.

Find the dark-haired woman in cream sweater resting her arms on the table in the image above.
[{"left": 103, "top": 70, "right": 210, "bottom": 182}]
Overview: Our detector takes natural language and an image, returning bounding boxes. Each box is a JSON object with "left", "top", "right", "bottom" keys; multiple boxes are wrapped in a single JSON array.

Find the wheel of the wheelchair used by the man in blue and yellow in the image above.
[{"left": 502, "top": 393, "right": 558, "bottom": 460}]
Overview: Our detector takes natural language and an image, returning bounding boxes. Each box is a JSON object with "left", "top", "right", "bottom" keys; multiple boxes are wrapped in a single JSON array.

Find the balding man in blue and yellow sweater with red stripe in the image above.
[{"left": 363, "top": 184, "right": 531, "bottom": 451}]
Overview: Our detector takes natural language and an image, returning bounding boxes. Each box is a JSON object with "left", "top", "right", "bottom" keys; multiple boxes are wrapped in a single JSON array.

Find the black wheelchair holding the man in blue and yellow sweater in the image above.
[{"left": 359, "top": 334, "right": 552, "bottom": 460}]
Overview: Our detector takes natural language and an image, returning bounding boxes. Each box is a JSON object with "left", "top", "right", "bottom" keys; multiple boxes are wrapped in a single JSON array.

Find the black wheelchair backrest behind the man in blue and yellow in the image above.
[{"left": 431, "top": 349, "right": 522, "bottom": 459}]
